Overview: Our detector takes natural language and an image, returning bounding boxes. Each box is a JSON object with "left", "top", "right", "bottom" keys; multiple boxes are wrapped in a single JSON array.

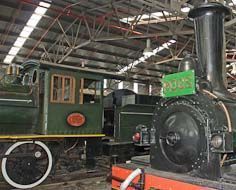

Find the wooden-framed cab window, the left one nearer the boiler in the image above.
[{"left": 51, "top": 75, "right": 75, "bottom": 104}]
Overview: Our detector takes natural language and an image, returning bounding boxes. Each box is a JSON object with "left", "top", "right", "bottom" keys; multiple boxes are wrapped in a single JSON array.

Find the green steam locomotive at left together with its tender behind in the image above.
[{"left": 0, "top": 61, "right": 159, "bottom": 189}]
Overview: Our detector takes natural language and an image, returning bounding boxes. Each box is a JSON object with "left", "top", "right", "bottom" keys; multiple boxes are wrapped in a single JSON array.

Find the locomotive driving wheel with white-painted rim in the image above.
[{"left": 1, "top": 141, "right": 52, "bottom": 189}]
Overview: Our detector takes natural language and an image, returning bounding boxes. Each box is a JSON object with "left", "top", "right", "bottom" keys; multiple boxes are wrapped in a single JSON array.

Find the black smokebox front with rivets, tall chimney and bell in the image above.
[{"left": 150, "top": 3, "right": 236, "bottom": 179}]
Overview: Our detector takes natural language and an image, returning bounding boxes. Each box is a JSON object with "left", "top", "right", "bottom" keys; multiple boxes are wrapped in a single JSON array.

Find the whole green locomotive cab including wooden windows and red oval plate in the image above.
[{"left": 37, "top": 65, "right": 103, "bottom": 136}]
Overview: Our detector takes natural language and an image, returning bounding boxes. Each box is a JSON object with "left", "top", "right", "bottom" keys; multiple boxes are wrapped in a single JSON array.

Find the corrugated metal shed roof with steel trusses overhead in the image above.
[{"left": 0, "top": 0, "right": 235, "bottom": 88}]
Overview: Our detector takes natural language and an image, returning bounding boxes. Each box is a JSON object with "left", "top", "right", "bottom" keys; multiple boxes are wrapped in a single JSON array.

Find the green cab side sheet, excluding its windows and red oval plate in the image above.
[{"left": 39, "top": 69, "right": 103, "bottom": 134}]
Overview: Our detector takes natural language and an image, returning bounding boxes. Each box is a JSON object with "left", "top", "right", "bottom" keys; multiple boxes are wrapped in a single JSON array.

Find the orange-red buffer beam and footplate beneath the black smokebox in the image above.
[{"left": 112, "top": 156, "right": 236, "bottom": 190}]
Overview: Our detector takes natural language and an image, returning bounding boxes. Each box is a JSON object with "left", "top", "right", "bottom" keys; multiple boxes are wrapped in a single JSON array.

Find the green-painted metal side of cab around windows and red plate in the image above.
[{"left": 37, "top": 68, "right": 103, "bottom": 135}]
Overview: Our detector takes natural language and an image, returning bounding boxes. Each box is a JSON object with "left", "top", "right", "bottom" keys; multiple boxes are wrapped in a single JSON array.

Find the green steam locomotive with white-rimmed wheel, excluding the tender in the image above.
[{"left": 0, "top": 61, "right": 104, "bottom": 189}]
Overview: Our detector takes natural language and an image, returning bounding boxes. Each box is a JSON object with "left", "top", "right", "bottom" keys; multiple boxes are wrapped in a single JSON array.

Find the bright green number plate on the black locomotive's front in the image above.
[{"left": 162, "top": 70, "right": 196, "bottom": 98}]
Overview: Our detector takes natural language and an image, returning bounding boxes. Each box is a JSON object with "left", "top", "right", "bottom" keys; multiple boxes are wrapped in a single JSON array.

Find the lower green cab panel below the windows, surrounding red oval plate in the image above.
[{"left": 46, "top": 104, "right": 102, "bottom": 134}]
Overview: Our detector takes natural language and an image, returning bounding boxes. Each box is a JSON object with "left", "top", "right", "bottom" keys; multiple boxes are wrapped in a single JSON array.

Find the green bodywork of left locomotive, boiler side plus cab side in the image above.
[{"left": 0, "top": 65, "right": 103, "bottom": 135}]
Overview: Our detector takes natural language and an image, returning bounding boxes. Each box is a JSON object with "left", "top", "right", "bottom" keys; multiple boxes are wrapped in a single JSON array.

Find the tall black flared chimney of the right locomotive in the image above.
[{"left": 189, "top": 2, "right": 235, "bottom": 100}]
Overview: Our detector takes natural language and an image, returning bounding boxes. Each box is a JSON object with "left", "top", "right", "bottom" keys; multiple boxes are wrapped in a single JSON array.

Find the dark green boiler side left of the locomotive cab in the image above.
[{"left": 0, "top": 83, "right": 38, "bottom": 135}]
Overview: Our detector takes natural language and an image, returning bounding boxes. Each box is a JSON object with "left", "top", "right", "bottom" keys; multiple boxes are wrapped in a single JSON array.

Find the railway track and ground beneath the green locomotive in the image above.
[{"left": 0, "top": 158, "right": 110, "bottom": 190}]
